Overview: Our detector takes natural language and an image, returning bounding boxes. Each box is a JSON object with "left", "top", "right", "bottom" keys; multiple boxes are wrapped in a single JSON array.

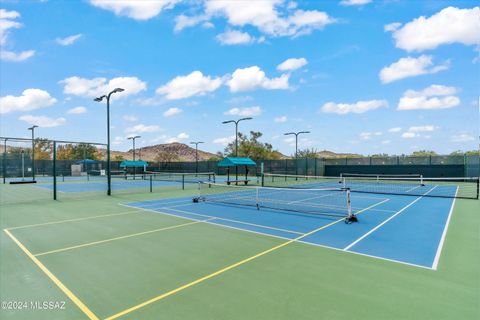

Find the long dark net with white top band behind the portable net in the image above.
[{"left": 262, "top": 174, "right": 479, "bottom": 199}]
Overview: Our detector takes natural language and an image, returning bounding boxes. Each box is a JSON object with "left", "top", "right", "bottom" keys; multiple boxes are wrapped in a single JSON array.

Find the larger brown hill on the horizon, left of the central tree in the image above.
[{"left": 112, "top": 142, "right": 215, "bottom": 161}]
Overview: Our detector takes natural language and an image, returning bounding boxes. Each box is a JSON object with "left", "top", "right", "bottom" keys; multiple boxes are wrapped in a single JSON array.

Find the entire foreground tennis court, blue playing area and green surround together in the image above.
[{"left": 1, "top": 175, "right": 480, "bottom": 319}]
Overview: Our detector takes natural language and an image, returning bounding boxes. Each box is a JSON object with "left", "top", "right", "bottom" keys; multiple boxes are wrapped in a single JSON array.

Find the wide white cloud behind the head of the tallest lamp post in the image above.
[{"left": 59, "top": 77, "right": 147, "bottom": 99}]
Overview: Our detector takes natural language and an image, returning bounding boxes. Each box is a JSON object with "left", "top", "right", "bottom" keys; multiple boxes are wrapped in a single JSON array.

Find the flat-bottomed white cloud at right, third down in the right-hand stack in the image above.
[{"left": 397, "top": 85, "right": 460, "bottom": 110}]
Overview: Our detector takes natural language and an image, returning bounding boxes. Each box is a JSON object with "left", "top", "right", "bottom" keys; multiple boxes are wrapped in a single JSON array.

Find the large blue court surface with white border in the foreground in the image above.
[{"left": 124, "top": 188, "right": 454, "bottom": 270}]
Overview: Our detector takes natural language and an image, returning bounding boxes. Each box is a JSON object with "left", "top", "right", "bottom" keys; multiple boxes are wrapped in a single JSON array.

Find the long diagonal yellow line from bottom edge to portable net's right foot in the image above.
[{"left": 105, "top": 218, "right": 345, "bottom": 320}]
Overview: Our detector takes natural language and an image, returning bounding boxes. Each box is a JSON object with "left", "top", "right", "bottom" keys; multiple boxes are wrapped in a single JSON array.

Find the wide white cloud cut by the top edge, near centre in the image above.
[{"left": 175, "top": 0, "right": 336, "bottom": 37}]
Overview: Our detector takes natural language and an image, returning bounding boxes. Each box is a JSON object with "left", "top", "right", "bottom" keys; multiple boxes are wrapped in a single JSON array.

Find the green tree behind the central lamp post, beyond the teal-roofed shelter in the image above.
[{"left": 224, "top": 131, "right": 280, "bottom": 160}]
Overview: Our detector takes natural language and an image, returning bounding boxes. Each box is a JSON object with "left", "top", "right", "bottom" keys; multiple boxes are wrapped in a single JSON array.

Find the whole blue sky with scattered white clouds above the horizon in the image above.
[{"left": 0, "top": 0, "right": 480, "bottom": 154}]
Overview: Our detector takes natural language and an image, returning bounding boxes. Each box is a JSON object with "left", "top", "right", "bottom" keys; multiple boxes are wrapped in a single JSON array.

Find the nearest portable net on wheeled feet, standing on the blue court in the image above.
[{"left": 193, "top": 182, "right": 357, "bottom": 222}]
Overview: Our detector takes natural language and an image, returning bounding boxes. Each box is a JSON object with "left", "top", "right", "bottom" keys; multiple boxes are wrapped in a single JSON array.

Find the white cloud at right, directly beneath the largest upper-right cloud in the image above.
[{"left": 379, "top": 55, "right": 448, "bottom": 83}]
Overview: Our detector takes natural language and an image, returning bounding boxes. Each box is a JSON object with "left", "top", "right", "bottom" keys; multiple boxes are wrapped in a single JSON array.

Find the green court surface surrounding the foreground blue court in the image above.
[{"left": 0, "top": 186, "right": 480, "bottom": 320}]
